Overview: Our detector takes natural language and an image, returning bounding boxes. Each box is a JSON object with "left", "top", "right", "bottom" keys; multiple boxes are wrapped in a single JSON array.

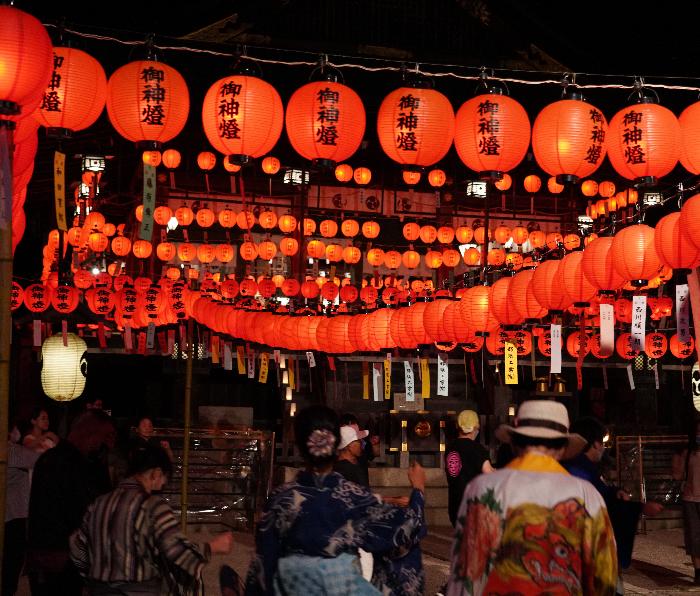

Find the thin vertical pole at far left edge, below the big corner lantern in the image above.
[{"left": 0, "top": 120, "right": 14, "bottom": 588}]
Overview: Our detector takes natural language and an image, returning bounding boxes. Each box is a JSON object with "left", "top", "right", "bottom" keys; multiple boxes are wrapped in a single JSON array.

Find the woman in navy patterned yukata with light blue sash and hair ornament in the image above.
[{"left": 246, "top": 405, "right": 426, "bottom": 596}]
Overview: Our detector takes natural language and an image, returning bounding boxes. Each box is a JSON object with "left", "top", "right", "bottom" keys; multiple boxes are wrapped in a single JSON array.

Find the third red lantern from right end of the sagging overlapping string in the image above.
[{"left": 612, "top": 224, "right": 661, "bottom": 286}]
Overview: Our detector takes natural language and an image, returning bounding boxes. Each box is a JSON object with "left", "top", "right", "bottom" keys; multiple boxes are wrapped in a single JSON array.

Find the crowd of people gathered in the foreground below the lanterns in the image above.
[{"left": 2, "top": 400, "right": 700, "bottom": 596}]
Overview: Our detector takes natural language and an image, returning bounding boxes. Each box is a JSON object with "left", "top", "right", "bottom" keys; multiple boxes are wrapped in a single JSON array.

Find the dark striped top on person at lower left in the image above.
[{"left": 70, "top": 478, "right": 210, "bottom": 593}]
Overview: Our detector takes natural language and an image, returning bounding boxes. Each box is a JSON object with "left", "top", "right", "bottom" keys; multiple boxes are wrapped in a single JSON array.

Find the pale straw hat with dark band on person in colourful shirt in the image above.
[{"left": 495, "top": 399, "right": 586, "bottom": 460}]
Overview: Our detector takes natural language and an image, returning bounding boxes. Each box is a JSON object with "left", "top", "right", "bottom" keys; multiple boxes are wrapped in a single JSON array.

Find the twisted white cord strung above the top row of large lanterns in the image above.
[{"left": 44, "top": 23, "right": 700, "bottom": 93}]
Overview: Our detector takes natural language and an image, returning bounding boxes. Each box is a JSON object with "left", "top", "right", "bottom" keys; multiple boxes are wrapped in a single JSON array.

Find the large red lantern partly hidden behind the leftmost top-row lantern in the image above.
[{"left": 33, "top": 47, "right": 107, "bottom": 133}]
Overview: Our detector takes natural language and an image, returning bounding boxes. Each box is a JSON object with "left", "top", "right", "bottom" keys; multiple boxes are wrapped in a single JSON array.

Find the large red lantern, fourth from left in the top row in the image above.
[{"left": 202, "top": 75, "right": 284, "bottom": 163}]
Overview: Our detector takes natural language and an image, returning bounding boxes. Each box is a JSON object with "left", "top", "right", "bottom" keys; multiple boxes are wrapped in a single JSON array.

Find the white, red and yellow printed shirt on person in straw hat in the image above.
[{"left": 447, "top": 453, "right": 617, "bottom": 596}]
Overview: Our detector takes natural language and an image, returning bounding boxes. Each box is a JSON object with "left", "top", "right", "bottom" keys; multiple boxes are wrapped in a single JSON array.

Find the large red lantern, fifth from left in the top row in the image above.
[{"left": 285, "top": 79, "right": 365, "bottom": 166}]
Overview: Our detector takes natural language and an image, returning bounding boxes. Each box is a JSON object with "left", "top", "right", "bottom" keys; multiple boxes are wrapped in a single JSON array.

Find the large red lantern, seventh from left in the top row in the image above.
[{"left": 455, "top": 91, "right": 530, "bottom": 179}]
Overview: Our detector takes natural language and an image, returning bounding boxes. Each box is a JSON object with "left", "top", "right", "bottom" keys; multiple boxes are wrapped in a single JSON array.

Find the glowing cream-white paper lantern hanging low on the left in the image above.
[{"left": 41, "top": 333, "right": 87, "bottom": 401}]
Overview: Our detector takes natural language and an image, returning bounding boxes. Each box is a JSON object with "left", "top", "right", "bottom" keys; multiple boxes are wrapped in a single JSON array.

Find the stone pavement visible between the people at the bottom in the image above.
[{"left": 18, "top": 526, "right": 700, "bottom": 596}]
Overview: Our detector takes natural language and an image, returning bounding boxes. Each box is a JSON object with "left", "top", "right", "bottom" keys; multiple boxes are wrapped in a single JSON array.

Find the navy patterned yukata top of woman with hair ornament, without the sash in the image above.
[{"left": 246, "top": 471, "right": 426, "bottom": 596}]
